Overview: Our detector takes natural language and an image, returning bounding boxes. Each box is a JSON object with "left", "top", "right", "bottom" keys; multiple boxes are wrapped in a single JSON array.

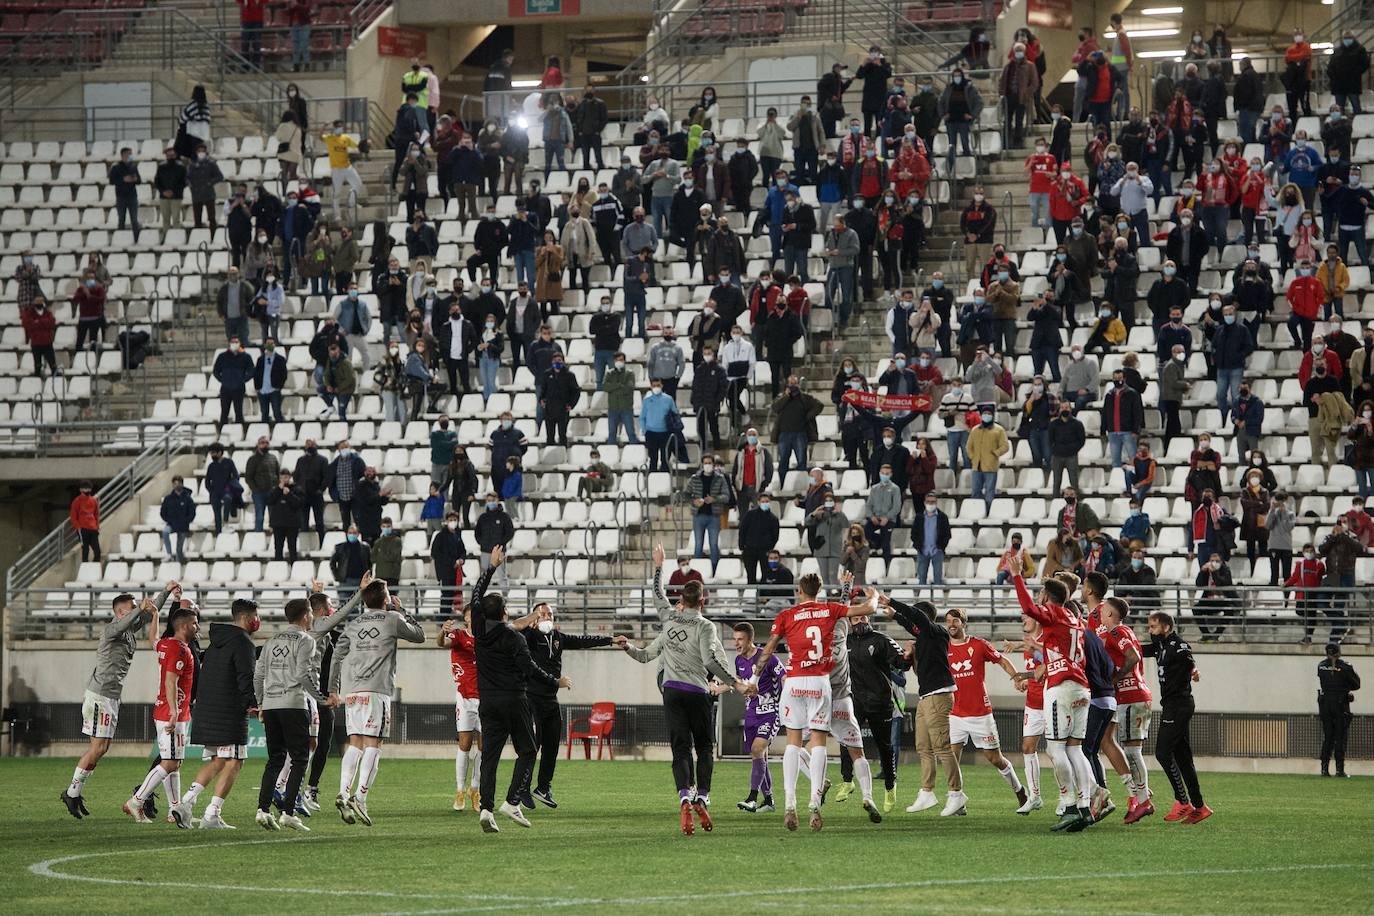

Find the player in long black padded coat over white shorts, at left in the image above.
[{"left": 179, "top": 597, "right": 261, "bottom": 829}]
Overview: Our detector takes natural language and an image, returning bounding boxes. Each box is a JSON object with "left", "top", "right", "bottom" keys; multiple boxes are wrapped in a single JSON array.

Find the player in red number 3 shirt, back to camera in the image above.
[{"left": 752, "top": 573, "right": 874, "bottom": 831}]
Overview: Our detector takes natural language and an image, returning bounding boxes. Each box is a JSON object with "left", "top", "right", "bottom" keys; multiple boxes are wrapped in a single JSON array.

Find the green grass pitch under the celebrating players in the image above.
[{"left": 0, "top": 758, "right": 1374, "bottom": 913}]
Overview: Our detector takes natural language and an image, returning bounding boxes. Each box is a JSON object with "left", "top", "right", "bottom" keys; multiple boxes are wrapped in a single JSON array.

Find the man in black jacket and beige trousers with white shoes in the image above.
[{"left": 878, "top": 593, "right": 965, "bottom": 814}]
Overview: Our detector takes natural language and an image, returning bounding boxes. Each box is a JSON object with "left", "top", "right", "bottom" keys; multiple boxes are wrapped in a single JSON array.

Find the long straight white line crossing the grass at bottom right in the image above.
[{"left": 362, "top": 862, "right": 1369, "bottom": 916}]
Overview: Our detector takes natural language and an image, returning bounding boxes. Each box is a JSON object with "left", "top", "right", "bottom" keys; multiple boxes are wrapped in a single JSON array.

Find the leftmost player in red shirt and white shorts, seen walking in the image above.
[{"left": 124, "top": 607, "right": 201, "bottom": 829}]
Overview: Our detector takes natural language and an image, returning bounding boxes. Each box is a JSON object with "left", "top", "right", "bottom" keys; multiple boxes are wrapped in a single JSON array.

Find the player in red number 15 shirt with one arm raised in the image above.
[{"left": 1011, "top": 575, "right": 1096, "bottom": 831}]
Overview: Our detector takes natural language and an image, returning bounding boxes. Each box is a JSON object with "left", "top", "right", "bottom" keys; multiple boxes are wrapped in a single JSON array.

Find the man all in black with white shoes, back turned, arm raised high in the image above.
[{"left": 470, "top": 547, "right": 573, "bottom": 834}]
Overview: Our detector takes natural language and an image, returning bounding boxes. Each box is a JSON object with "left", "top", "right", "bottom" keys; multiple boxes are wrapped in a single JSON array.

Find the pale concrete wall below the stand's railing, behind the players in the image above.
[{"left": 4, "top": 637, "right": 1374, "bottom": 714}]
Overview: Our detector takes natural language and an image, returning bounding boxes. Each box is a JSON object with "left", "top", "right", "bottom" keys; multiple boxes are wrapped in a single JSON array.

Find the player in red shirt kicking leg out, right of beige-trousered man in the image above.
[{"left": 945, "top": 607, "right": 1028, "bottom": 805}]
